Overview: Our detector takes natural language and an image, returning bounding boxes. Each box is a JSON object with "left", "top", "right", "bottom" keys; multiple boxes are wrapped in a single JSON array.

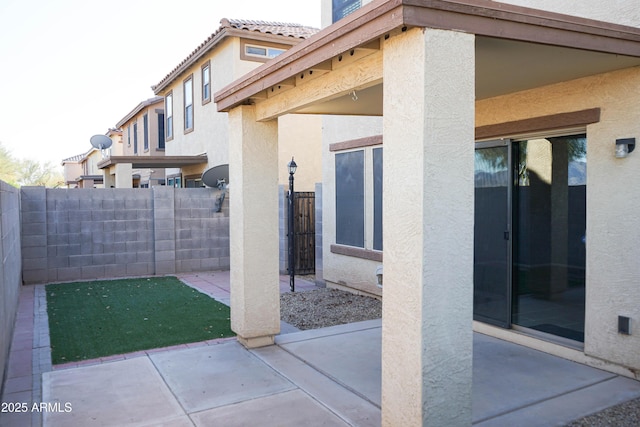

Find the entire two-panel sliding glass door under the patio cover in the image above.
[{"left": 474, "top": 134, "right": 587, "bottom": 342}]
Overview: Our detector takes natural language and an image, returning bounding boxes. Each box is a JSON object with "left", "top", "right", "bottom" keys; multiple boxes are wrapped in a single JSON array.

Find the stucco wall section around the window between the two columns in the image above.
[{"left": 322, "top": 116, "right": 386, "bottom": 295}]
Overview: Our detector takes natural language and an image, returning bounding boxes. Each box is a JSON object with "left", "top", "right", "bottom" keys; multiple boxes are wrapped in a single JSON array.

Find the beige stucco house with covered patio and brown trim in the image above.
[{"left": 214, "top": 0, "right": 640, "bottom": 426}]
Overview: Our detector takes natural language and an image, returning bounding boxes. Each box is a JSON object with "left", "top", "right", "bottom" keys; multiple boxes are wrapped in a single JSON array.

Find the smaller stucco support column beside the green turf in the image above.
[{"left": 229, "top": 106, "right": 286, "bottom": 347}]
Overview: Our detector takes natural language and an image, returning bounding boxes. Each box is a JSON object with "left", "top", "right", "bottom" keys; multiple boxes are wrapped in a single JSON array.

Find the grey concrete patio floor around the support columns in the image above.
[{"left": 0, "top": 272, "right": 640, "bottom": 427}]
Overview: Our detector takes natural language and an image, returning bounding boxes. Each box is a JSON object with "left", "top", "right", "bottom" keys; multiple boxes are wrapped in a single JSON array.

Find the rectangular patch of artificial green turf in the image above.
[{"left": 46, "top": 277, "right": 234, "bottom": 364}]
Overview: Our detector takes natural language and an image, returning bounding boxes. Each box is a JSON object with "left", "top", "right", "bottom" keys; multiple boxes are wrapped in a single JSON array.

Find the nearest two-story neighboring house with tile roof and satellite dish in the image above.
[{"left": 153, "top": 19, "right": 321, "bottom": 191}]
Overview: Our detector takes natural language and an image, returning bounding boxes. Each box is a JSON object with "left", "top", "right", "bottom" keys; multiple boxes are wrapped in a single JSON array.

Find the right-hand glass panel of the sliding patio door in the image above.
[{"left": 513, "top": 135, "right": 587, "bottom": 342}]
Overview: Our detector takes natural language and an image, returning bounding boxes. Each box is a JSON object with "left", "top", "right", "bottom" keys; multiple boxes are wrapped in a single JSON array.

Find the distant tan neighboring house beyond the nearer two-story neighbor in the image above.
[{"left": 100, "top": 97, "right": 165, "bottom": 188}]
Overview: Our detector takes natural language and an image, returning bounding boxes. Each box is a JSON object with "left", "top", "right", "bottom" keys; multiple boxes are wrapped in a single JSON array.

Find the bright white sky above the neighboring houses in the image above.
[{"left": 0, "top": 0, "right": 321, "bottom": 165}]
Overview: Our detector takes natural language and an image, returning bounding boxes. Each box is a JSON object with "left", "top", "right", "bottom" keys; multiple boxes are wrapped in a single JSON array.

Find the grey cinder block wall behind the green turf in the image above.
[{"left": 21, "top": 187, "right": 229, "bottom": 284}]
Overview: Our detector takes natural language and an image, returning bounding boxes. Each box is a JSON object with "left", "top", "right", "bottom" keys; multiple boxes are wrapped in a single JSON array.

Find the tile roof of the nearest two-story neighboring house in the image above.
[{"left": 151, "top": 18, "right": 320, "bottom": 93}]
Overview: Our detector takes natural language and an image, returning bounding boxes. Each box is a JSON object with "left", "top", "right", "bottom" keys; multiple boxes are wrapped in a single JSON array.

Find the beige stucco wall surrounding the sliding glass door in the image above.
[{"left": 476, "top": 68, "right": 640, "bottom": 370}]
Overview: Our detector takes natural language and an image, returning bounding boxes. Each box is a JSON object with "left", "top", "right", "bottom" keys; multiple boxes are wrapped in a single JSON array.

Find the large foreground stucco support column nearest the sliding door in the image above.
[{"left": 382, "top": 28, "right": 475, "bottom": 426}]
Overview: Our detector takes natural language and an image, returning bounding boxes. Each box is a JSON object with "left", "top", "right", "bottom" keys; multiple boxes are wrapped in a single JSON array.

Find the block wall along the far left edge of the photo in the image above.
[{"left": 0, "top": 181, "right": 22, "bottom": 392}]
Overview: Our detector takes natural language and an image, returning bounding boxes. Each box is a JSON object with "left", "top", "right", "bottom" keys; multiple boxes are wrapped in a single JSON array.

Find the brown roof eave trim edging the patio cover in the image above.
[{"left": 214, "top": 0, "right": 640, "bottom": 111}]
